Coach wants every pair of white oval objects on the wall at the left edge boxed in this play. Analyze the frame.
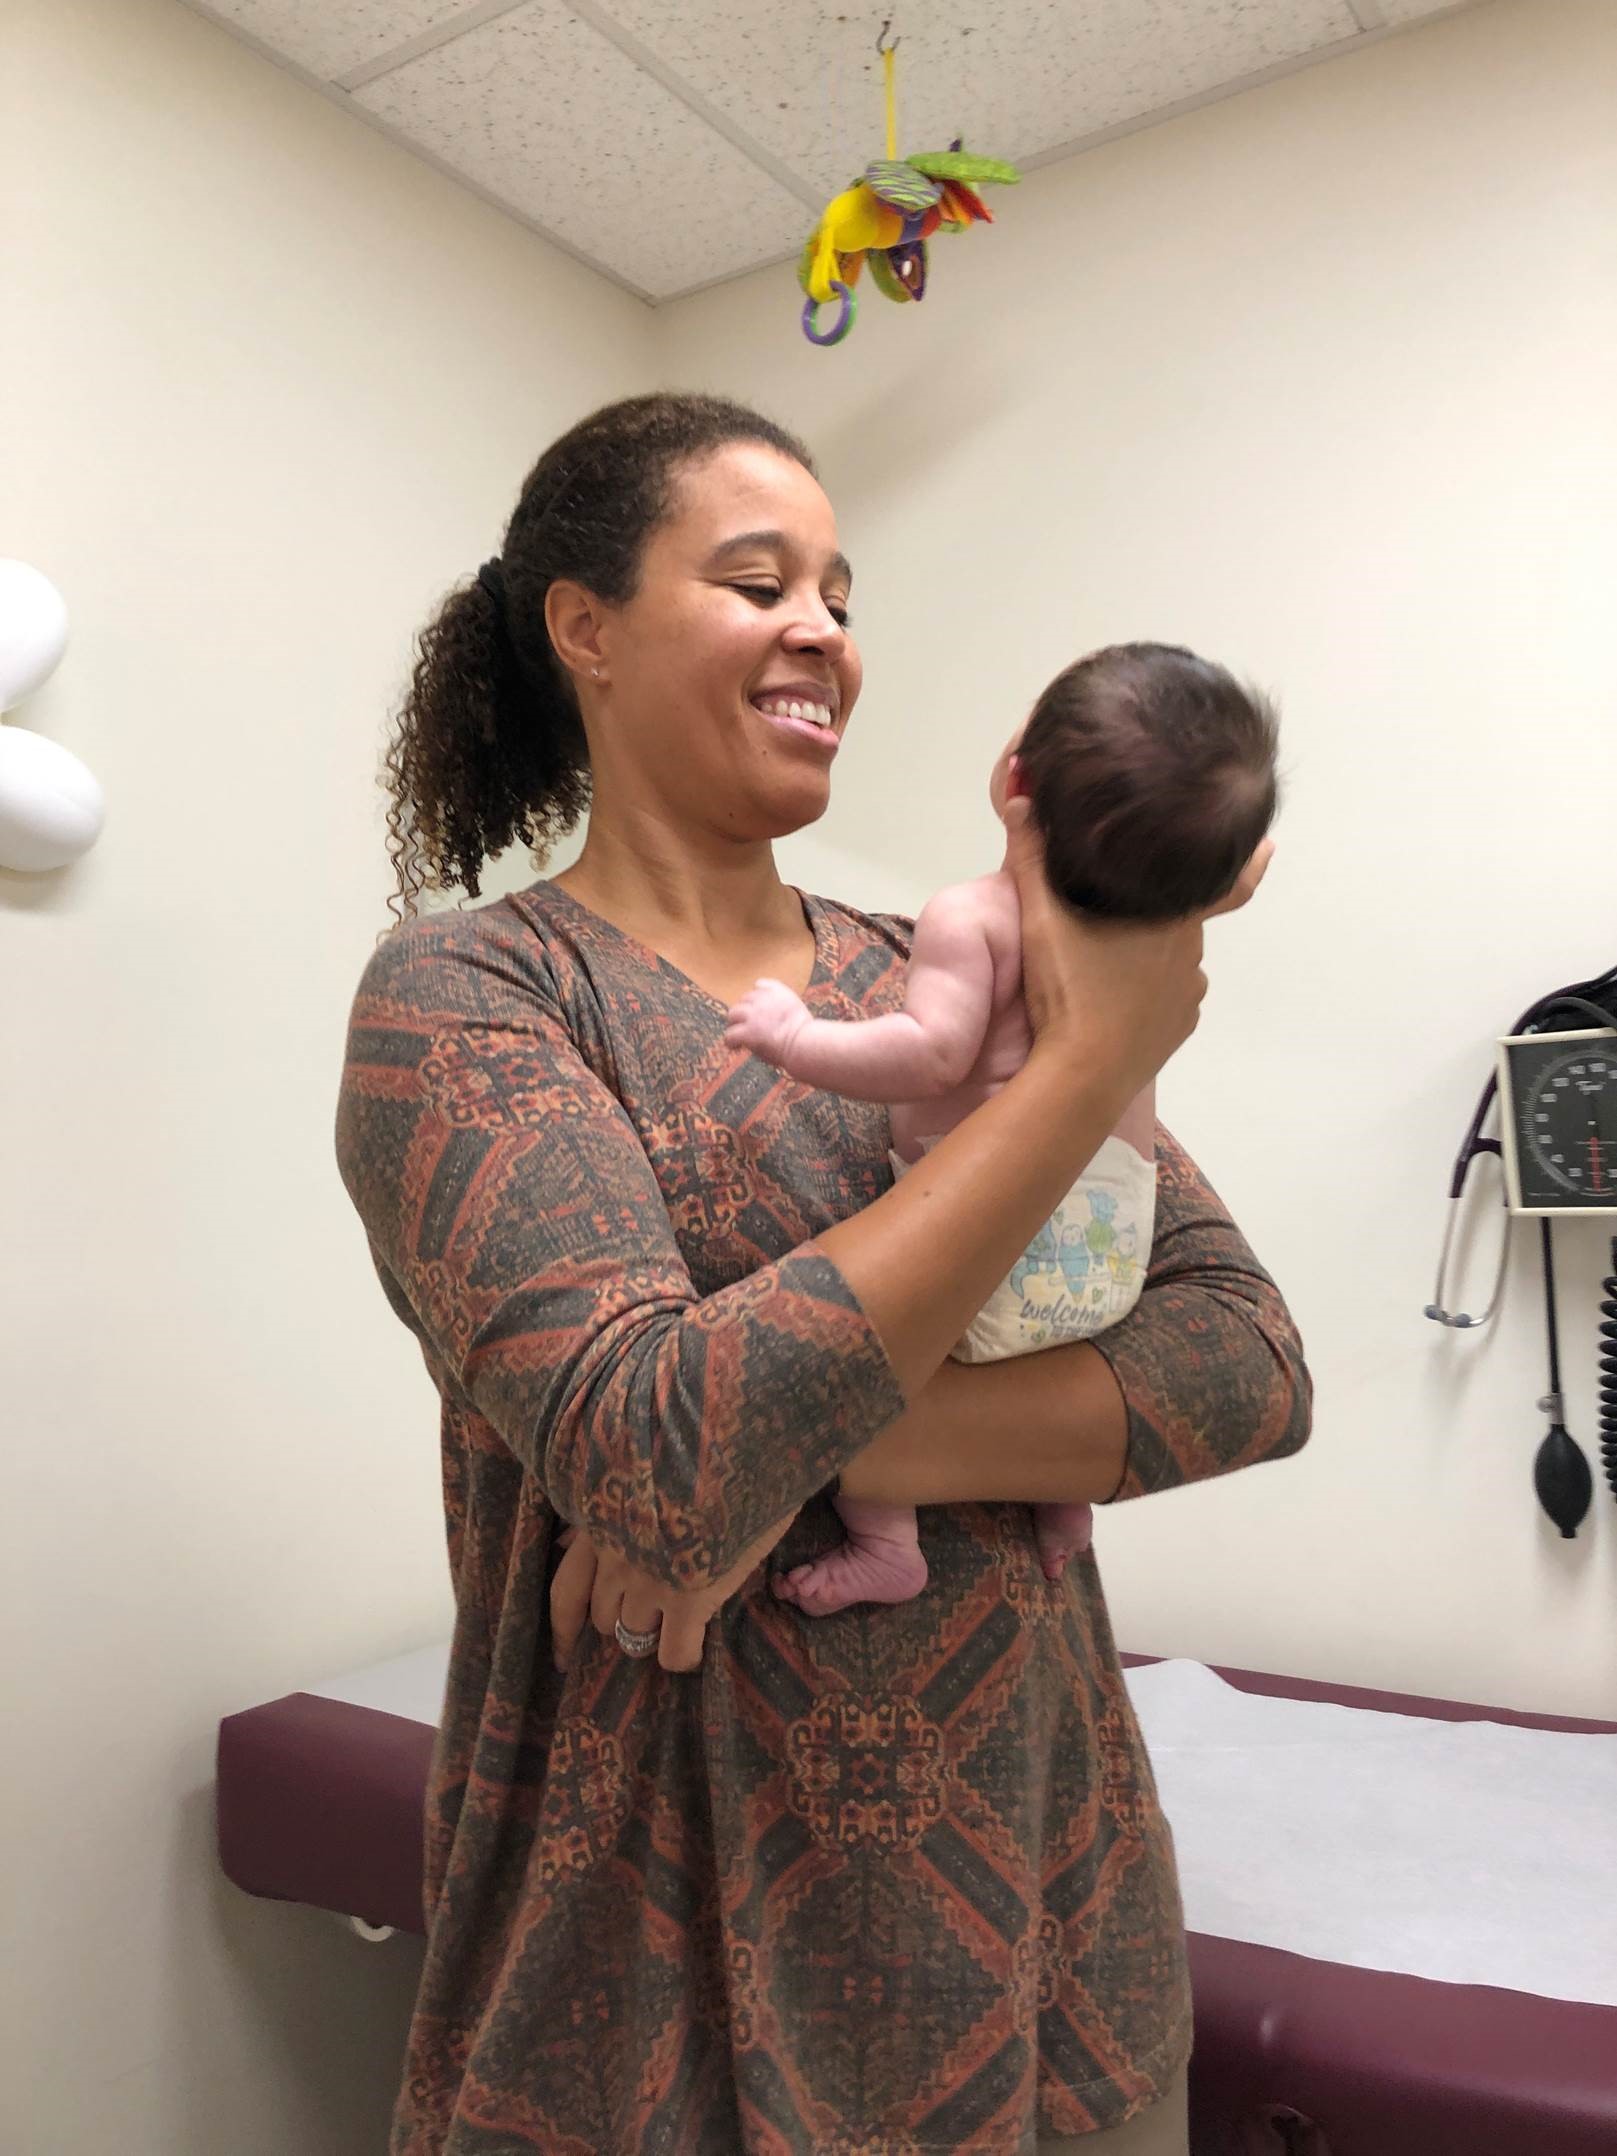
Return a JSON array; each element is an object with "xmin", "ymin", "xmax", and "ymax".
[{"xmin": 0, "ymin": 556, "xmax": 106, "ymax": 875}]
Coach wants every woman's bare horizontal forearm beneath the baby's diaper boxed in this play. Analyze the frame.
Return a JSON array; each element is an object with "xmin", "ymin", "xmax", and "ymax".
[{"xmin": 841, "ymin": 1341, "xmax": 1128, "ymax": 1505}]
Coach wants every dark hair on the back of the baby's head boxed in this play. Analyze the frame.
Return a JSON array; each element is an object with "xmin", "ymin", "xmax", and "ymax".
[{"xmin": 1018, "ymin": 645, "xmax": 1279, "ymax": 921}]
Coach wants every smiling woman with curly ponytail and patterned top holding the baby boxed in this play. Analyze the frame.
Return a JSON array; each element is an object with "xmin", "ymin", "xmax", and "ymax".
[{"xmin": 338, "ymin": 397, "xmax": 1309, "ymax": 2156}]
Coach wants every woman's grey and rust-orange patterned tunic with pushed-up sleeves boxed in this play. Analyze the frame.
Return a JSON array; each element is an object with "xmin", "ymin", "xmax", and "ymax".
[{"xmin": 338, "ymin": 884, "xmax": 1309, "ymax": 2156}]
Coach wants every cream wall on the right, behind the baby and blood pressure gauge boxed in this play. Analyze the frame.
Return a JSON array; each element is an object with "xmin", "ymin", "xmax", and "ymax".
[{"xmin": 664, "ymin": 0, "xmax": 1617, "ymax": 1714}]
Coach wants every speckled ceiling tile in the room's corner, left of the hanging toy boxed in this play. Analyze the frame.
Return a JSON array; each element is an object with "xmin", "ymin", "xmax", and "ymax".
[{"xmin": 354, "ymin": 0, "xmax": 813, "ymax": 298}]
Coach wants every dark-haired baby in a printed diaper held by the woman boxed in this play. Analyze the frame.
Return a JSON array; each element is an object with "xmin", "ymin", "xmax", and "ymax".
[{"xmin": 724, "ymin": 645, "xmax": 1279, "ymax": 1617}]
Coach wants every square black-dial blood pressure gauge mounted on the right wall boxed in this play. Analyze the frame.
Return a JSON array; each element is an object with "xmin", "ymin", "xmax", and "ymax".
[{"xmin": 1498, "ymin": 1026, "xmax": 1617, "ymax": 1214}]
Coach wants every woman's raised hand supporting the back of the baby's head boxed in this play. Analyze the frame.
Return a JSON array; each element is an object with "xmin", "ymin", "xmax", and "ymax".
[{"xmin": 1005, "ymin": 793, "xmax": 1274, "ymax": 1100}]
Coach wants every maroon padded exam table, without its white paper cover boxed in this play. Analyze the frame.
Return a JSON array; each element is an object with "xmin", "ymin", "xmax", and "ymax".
[{"xmin": 218, "ymin": 1656, "xmax": 1617, "ymax": 2156}]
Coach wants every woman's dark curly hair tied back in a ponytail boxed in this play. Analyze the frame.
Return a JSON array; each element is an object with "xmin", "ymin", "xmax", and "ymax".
[{"xmin": 384, "ymin": 392, "xmax": 815, "ymax": 914}]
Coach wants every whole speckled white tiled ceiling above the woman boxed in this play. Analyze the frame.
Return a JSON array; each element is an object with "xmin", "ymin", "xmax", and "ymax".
[{"xmin": 190, "ymin": 0, "xmax": 1475, "ymax": 300}]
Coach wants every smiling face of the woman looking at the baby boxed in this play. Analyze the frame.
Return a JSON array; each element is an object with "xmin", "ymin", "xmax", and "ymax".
[{"xmin": 580, "ymin": 442, "xmax": 860, "ymax": 841}]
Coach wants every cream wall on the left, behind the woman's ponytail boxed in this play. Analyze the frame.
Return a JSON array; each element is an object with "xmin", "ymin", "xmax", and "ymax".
[{"xmin": 0, "ymin": 0, "xmax": 653, "ymax": 2156}]
